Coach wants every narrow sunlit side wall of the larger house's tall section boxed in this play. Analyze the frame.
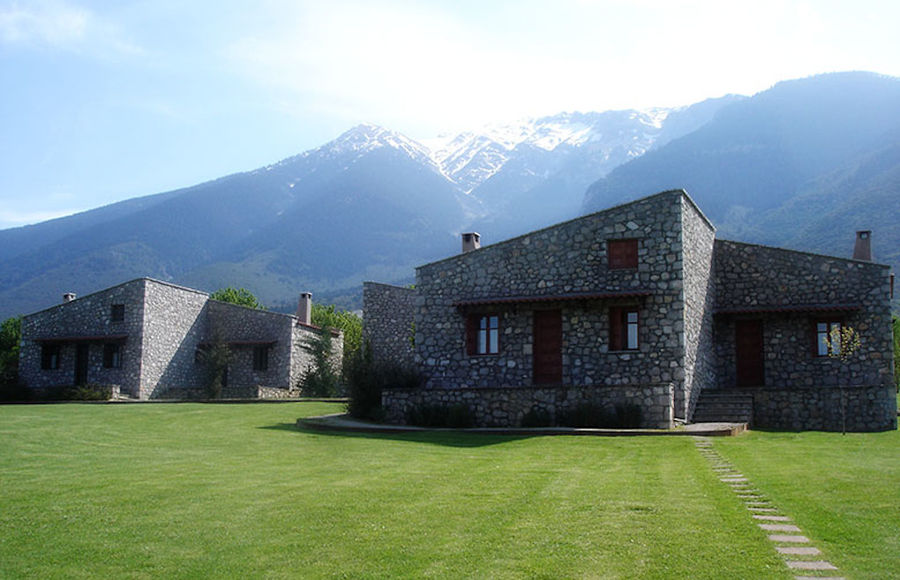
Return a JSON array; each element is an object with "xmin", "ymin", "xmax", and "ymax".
[{"xmin": 675, "ymin": 196, "xmax": 716, "ymax": 419}]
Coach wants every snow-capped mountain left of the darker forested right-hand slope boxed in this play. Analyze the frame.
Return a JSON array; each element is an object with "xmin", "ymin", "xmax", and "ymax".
[{"xmin": 0, "ymin": 97, "xmax": 737, "ymax": 318}]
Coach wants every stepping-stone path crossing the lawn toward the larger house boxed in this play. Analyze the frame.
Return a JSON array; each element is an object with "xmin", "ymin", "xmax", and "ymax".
[{"xmin": 694, "ymin": 437, "xmax": 844, "ymax": 580}]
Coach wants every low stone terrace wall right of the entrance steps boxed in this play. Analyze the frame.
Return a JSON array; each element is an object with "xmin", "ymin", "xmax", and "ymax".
[{"xmin": 741, "ymin": 385, "xmax": 897, "ymax": 431}]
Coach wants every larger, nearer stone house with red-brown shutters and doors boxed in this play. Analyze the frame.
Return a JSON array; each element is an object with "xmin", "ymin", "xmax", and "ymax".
[{"xmin": 364, "ymin": 190, "xmax": 897, "ymax": 430}]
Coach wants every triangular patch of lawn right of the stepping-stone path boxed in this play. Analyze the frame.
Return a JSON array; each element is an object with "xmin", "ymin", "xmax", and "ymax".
[{"xmin": 715, "ymin": 431, "xmax": 900, "ymax": 579}]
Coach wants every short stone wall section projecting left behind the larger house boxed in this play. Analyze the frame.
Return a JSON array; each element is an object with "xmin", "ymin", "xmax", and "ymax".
[{"xmin": 363, "ymin": 282, "xmax": 416, "ymax": 364}]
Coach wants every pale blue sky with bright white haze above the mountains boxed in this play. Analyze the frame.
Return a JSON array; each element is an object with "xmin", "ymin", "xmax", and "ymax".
[{"xmin": 0, "ymin": 0, "xmax": 900, "ymax": 229}]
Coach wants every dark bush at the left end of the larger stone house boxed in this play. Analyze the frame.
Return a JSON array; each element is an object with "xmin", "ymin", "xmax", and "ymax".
[{"xmin": 344, "ymin": 343, "xmax": 422, "ymax": 421}]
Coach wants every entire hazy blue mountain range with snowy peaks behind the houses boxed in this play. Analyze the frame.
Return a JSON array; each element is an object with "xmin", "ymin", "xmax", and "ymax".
[{"xmin": 0, "ymin": 73, "xmax": 900, "ymax": 318}]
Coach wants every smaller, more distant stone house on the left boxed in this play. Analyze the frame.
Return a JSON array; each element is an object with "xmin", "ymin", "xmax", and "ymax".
[{"xmin": 19, "ymin": 278, "xmax": 343, "ymax": 399}]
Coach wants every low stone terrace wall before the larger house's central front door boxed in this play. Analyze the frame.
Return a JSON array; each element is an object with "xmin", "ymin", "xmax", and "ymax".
[{"xmin": 381, "ymin": 383, "xmax": 674, "ymax": 429}]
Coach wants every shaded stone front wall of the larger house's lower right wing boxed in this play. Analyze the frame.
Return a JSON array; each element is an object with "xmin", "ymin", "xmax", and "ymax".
[{"xmin": 715, "ymin": 240, "xmax": 893, "ymax": 388}]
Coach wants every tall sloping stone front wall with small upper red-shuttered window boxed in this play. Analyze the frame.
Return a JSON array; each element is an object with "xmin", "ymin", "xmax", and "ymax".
[{"xmin": 416, "ymin": 191, "xmax": 685, "ymax": 392}]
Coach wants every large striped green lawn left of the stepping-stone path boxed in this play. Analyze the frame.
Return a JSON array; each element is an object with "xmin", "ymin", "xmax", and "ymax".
[{"xmin": 7, "ymin": 403, "xmax": 796, "ymax": 578}]
